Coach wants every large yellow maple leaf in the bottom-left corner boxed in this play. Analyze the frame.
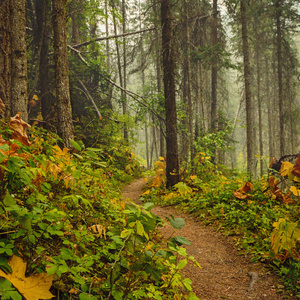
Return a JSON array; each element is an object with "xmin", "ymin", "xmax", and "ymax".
[{"xmin": 0, "ymin": 255, "xmax": 54, "ymax": 300}]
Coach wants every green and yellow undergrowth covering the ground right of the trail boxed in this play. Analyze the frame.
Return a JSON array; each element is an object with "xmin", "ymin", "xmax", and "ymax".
[{"xmin": 142, "ymin": 152, "xmax": 300, "ymax": 298}]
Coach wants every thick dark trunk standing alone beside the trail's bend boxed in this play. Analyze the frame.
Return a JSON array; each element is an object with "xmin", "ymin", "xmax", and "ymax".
[{"xmin": 161, "ymin": 0, "xmax": 179, "ymax": 187}]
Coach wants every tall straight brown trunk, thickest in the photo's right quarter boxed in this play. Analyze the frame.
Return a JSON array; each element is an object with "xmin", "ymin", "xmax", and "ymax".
[{"xmin": 241, "ymin": 0, "xmax": 255, "ymax": 175}]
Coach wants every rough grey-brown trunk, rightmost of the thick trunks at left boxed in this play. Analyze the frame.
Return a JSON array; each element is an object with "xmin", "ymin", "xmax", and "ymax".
[{"xmin": 52, "ymin": 0, "xmax": 74, "ymax": 148}]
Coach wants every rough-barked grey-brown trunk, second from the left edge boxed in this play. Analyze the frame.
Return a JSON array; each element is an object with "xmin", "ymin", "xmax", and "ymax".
[{"xmin": 10, "ymin": 0, "xmax": 28, "ymax": 122}]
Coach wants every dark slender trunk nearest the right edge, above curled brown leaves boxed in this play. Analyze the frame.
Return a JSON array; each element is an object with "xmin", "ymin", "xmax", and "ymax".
[{"xmin": 275, "ymin": 0, "xmax": 284, "ymax": 156}]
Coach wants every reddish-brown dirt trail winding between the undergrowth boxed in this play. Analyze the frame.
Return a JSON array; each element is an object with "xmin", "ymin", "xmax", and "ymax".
[{"xmin": 122, "ymin": 179, "xmax": 296, "ymax": 300}]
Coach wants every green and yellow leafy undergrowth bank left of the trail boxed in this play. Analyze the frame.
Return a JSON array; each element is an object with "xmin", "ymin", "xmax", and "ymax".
[{"xmin": 0, "ymin": 115, "xmax": 198, "ymax": 300}]
